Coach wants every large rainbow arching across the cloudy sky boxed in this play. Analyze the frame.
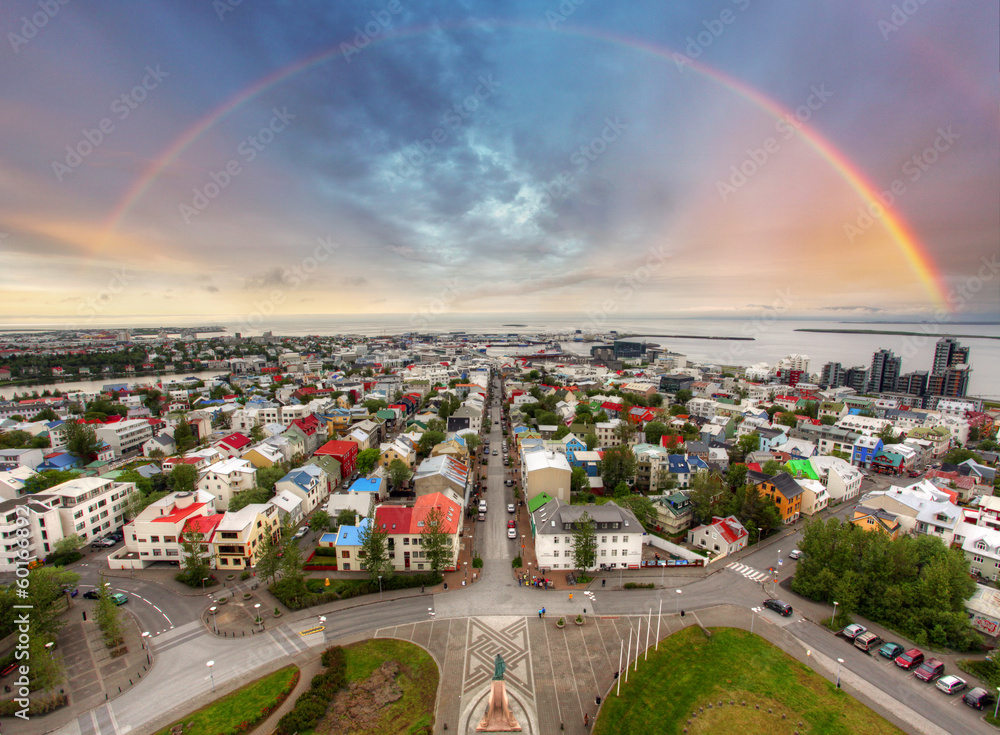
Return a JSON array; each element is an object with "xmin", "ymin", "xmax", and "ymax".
[{"xmin": 102, "ymin": 20, "xmax": 951, "ymax": 310}]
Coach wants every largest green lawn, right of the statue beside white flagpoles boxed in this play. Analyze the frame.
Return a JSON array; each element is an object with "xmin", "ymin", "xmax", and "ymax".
[{"xmin": 594, "ymin": 627, "xmax": 902, "ymax": 735}]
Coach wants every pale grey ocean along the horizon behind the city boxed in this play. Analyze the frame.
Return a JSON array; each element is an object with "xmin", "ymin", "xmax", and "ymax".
[{"xmin": 0, "ymin": 314, "xmax": 1000, "ymax": 399}]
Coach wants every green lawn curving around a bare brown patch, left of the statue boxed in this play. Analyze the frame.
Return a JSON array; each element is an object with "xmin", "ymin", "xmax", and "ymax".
[{"xmin": 324, "ymin": 638, "xmax": 438, "ymax": 735}]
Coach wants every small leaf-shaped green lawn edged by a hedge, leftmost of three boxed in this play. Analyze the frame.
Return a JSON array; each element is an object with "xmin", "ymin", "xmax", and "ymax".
[{"xmin": 148, "ymin": 665, "xmax": 299, "ymax": 735}]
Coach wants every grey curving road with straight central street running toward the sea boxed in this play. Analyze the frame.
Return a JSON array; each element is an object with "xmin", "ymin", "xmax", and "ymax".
[{"xmin": 43, "ymin": 391, "xmax": 994, "ymax": 735}]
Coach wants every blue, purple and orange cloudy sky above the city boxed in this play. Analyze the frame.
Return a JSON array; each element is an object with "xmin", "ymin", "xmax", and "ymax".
[{"xmin": 0, "ymin": 0, "xmax": 1000, "ymax": 324}]
